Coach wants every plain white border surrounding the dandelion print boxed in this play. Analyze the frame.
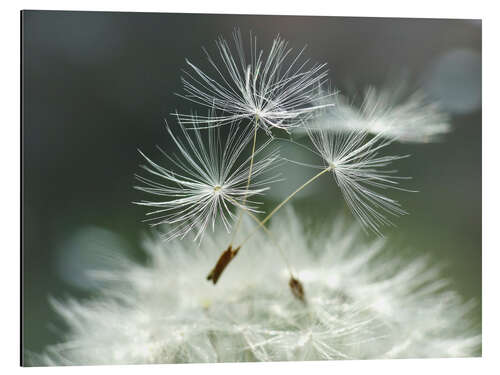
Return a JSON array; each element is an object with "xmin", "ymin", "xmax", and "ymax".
[{"xmin": 0, "ymin": 0, "xmax": 500, "ymax": 375}]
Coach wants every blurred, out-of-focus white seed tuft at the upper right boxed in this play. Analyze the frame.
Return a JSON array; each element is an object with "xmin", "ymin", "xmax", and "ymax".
[{"xmin": 297, "ymin": 84, "xmax": 451, "ymax": 143}]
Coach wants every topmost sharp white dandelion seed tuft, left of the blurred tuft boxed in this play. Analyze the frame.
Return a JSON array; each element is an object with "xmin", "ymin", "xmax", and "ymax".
[{"xmin": 179, "ymin": 30, "xmax": 332, "ymax": 133}]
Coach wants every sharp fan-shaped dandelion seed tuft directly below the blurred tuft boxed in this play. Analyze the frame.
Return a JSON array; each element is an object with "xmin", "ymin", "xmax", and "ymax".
[{"xmin": 309, "ymin": 130, "xmax": 410, "ymax": 235}]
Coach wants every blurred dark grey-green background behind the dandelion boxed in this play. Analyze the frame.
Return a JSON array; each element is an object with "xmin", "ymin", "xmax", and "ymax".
[{"xmin": 22, "ymin": 11, "xmax": 481, "ymax": 358}]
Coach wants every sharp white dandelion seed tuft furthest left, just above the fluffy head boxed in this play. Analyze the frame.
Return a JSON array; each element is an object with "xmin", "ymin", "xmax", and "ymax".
[{"xmin": 135, "ymin": 117, "xmax": 278, "ymax": 240}]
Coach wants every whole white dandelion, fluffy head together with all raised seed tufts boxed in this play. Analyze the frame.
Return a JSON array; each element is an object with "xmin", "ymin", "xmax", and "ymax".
[{"xmin": 32, "ymin": 30, "xmax": 470, "ymax": 365}]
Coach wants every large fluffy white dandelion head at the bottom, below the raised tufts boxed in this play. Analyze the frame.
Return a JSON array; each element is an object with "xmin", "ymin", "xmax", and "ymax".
[{"xmin": 32, "ymin": 211, "xmax": 481, "ymax": 365}]
